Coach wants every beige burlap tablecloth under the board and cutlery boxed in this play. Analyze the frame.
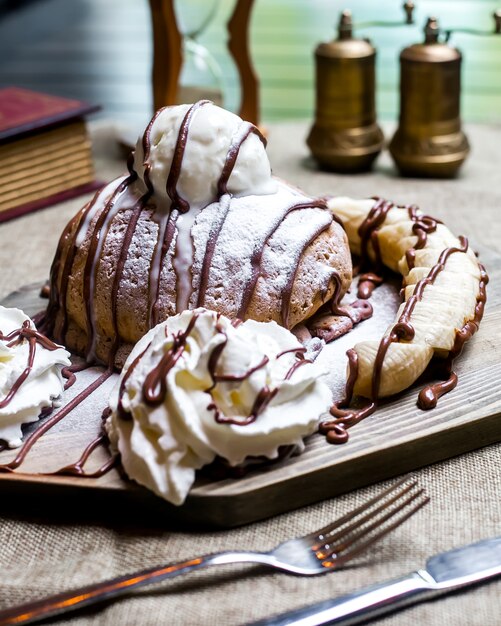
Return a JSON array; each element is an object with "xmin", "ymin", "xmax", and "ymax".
[{"xmin": 0, "ymin": 119, "xmax": 501, "ymax": 626}]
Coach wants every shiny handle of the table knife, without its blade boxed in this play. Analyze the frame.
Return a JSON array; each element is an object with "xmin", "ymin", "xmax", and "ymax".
[{"xmin": 252, "ymin": 570, "xmax": 436, "ymax": 626}]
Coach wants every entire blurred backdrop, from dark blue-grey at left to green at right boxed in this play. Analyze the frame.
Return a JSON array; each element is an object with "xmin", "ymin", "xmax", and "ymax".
[{"xmin": 0, "ymin": 0, "xmax": 501, "ymax": 126}]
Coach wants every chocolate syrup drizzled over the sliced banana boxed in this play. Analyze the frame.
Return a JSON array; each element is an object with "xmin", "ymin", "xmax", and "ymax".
[{"xmin": 319, "ymin": 200, "xmax": 488, "ymax": 444}]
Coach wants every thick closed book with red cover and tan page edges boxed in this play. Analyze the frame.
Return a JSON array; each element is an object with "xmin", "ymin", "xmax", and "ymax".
[{"xmin": 0, "ymin": 87, "xmax": 99, "ymax": 222}]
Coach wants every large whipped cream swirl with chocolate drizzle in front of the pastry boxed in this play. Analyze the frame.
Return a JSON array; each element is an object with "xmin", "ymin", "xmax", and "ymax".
[{"xmin": 107, "ymin": 309, "xmax": 332, "ymax": 505}]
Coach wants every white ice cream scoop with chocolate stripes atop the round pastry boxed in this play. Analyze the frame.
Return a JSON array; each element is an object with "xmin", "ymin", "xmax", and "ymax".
[{"xmin": 134, "ymin": 103, "xmax": 277, "ymax": 207}]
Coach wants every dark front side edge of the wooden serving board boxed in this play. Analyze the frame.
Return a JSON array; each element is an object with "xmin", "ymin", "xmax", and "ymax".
[{"xmin": 1, "ymin": 404, "xmax": 501, "ymax": 530}]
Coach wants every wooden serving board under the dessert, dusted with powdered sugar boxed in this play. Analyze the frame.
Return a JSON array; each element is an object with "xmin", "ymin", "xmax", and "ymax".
[{"xmin": 0, "ymin": 241, "xmax": 501, "ymax": 528}]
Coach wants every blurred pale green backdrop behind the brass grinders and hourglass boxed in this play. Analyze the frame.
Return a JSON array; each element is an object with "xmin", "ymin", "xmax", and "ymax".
[{"xmin": 186, "ymin": 0, "xmax": 501, "ymax": 122}]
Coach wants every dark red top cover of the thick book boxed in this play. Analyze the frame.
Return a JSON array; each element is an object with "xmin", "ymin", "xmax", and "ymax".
[{"xmin": 0, "ymin": 87, "xmax": 100, "ymax": 144}]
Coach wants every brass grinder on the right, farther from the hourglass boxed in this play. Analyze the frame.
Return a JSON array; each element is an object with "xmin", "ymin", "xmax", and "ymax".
[{"xmin": 389, "ymin": 17, "xmax": 470, "ymax": 178}]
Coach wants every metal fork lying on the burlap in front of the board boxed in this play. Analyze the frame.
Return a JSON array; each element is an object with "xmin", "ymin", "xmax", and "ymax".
[{"xmin": 0, "ymin": 478, "xmax": 429, "ymax": 626}]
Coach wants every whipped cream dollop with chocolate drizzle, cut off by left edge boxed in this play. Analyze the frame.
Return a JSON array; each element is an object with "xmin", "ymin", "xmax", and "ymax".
[{"xmin": 0, "ymin": 306, "xmax": 71, "ymax": 448}]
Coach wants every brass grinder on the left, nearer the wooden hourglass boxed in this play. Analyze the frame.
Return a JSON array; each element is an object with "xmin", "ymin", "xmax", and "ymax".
[{"xmin": 306, "ymin": 11, "xmax": 383, "ymax": 172}]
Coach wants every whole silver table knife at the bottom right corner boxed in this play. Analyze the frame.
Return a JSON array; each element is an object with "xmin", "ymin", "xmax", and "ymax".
[{"xmin": 249, "ymin": 537, "xmax": 501, "ymax": 626}]
